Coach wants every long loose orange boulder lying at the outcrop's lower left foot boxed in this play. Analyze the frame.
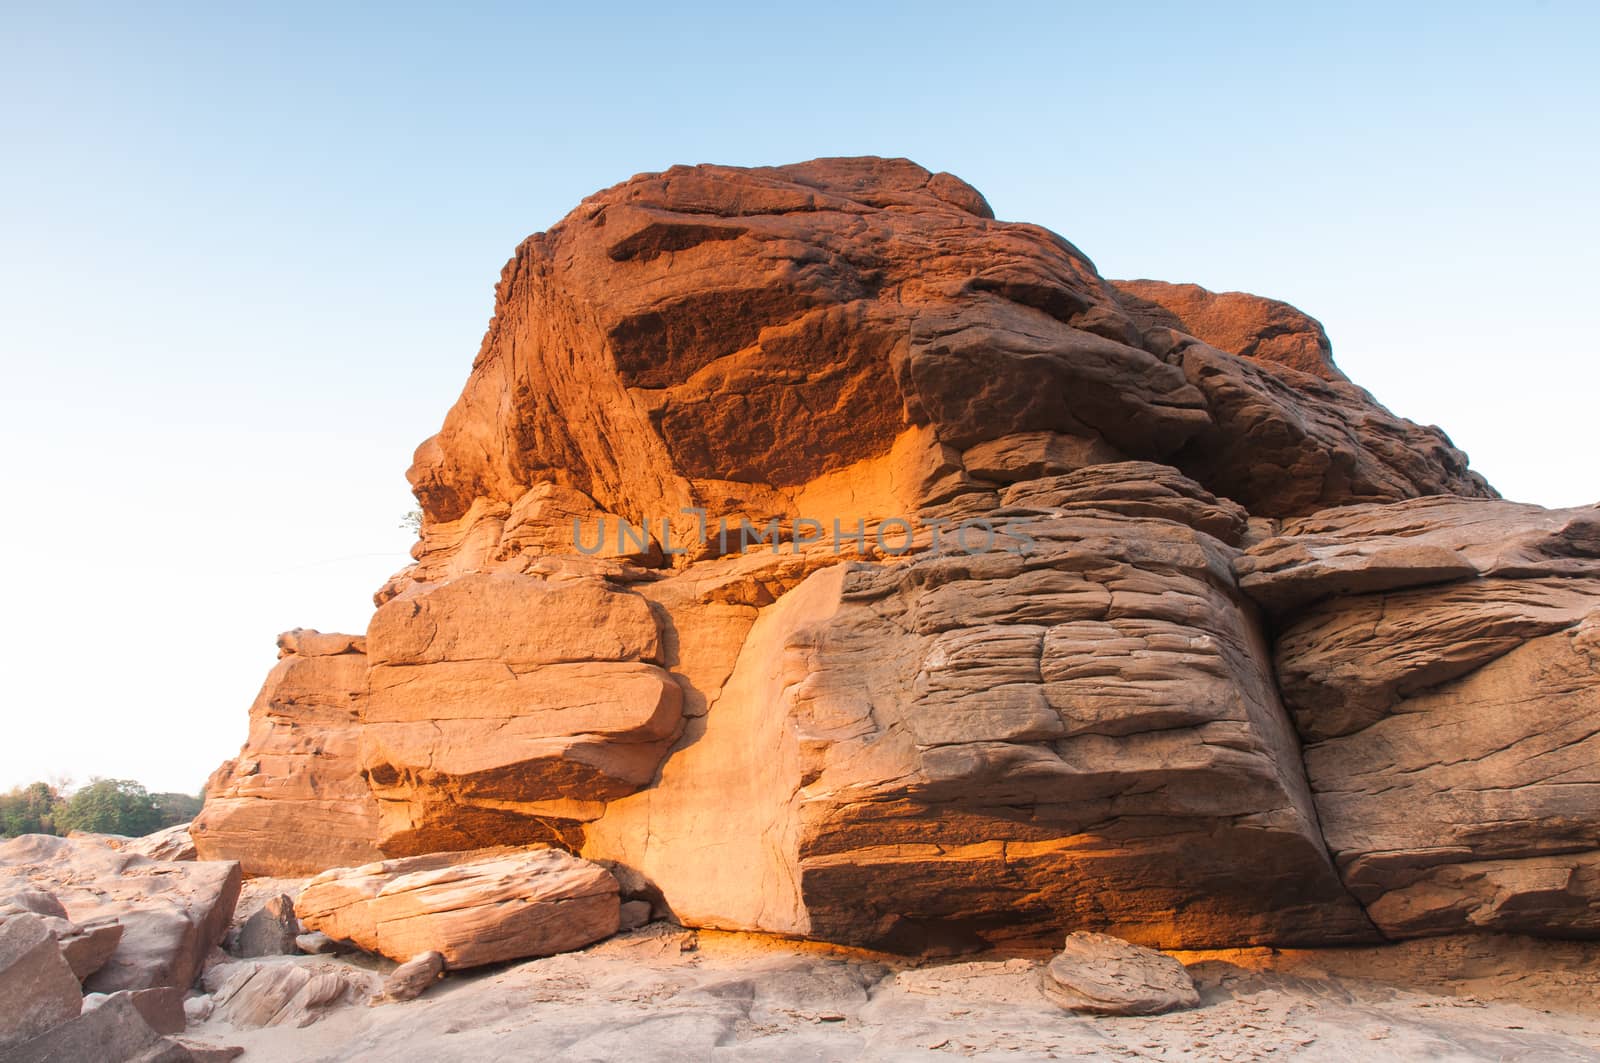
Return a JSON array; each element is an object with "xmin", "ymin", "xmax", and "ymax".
[{"xmin": 294, "ymin": 848, "xmax": 619, "ymax": 970}]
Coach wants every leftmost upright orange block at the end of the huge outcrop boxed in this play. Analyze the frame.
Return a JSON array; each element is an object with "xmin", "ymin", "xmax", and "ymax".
[{"xmin": 190, "ymin": 629, "xmax": 381, "ymax": 876}]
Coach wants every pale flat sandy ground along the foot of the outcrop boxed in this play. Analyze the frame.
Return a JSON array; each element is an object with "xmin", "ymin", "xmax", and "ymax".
[{"xmin": 187, "ymin": 925, "xmax": 1600, "ymax": 1063}]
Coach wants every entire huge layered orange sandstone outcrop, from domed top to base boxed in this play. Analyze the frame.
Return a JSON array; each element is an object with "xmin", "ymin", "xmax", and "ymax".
[{"xmin": 195, "ymin": 158, "xmax": 1600, "ymax": 965}]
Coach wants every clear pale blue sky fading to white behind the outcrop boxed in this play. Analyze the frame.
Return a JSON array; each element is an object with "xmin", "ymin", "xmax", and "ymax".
[{"xmin": 0, "ymin": 2, "xmax": 1600, "ymax": 791}]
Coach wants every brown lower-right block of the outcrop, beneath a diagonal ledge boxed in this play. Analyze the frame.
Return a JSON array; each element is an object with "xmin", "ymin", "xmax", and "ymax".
[{"xmin": 1306, "ymin": 614, "xmax": 1600, "ymax": 937}]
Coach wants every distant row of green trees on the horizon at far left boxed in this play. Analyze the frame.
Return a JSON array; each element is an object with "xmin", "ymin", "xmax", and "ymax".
[{"xmin": 0, "ymin": 778, "xmax": 202, "ymax": 837}]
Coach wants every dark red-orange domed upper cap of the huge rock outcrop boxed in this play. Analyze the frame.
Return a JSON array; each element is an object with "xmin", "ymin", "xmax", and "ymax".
[{"xmin": 396, "ymin": 158, "xmax": 1485, "ymax": 563}]
